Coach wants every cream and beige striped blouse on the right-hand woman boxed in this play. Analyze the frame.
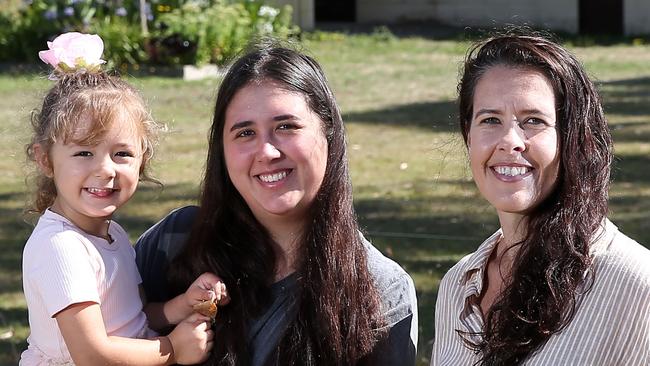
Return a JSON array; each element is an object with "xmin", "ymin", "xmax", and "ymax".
[{"xmin": 431, "ymin": 220, "xmax": 650, "ymax": 366}]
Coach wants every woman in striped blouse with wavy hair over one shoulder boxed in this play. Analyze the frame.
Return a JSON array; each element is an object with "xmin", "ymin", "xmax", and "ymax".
[{"xmin": 431, "ymin": 30, "xmax": 650, "ymax": 366}]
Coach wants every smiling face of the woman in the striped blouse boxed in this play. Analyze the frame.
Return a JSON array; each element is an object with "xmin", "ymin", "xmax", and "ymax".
[{"xmin": 468, "ymin": 66, "xmax": 560, "ymax": 217}]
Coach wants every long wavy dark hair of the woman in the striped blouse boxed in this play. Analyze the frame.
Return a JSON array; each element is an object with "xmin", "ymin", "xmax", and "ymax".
[{"xmin": 458, "ymin": 29, "xmax": 612, "ymax": 365}]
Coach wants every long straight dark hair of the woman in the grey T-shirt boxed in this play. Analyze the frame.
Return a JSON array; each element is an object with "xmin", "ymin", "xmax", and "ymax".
[{"xmin": 170, "ymin": 45, "xmax": 382, "ymax": 365}]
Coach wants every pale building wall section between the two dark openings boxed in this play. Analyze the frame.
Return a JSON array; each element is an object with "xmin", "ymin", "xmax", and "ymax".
[{"xmin": 357, "ymin": 0, "xmax": 576, "ymax": 32}]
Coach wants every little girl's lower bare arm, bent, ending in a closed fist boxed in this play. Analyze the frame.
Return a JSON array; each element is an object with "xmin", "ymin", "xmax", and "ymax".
[{"xmin": 55, "ymin": 302, "xmax": 214, "ymax": 366}]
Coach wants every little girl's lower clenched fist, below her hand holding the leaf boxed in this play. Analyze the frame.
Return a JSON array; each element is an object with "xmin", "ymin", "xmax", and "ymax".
[{"xmin": 167, "ymin": 313, "xmax": 214, "ymax": 365}]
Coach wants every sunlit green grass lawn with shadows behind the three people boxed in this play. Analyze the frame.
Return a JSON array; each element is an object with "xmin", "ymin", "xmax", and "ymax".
[{"xmin": 0, "ymin": 27, "xmax": 650, "ymax": 365}]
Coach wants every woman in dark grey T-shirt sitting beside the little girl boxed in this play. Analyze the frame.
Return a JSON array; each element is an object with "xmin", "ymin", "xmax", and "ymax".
[{"xmin": 136, "ymin": 46, "xmax": 417, "ymax": 365}]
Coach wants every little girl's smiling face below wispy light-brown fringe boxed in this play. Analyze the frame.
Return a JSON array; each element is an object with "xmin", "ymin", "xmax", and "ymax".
[{"xmin": 39, "ymin": 113, "xmax": 142, "ymax": 236}]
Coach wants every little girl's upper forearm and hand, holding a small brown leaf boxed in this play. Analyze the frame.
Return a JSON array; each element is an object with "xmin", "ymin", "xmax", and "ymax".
[{"xmin": 140, "ymin": 272, "xmax": 229, "ymax": 330}]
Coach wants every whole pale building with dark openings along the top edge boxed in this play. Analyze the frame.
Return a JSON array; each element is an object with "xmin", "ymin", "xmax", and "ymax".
[{"xmin": 275, "ymin": 0, "xmax": 650, "ymax": 35}]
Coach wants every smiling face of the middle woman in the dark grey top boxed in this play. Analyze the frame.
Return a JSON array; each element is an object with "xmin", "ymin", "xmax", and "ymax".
[{"xmin": 223, "ymin": 81, "xmax": 327, "ymax": 226}]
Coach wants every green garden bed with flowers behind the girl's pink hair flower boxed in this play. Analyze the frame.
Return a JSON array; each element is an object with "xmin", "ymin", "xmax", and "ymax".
[{"xmin": 0, "ymin": 0, "xmax": 299, "ymax": 69}]
